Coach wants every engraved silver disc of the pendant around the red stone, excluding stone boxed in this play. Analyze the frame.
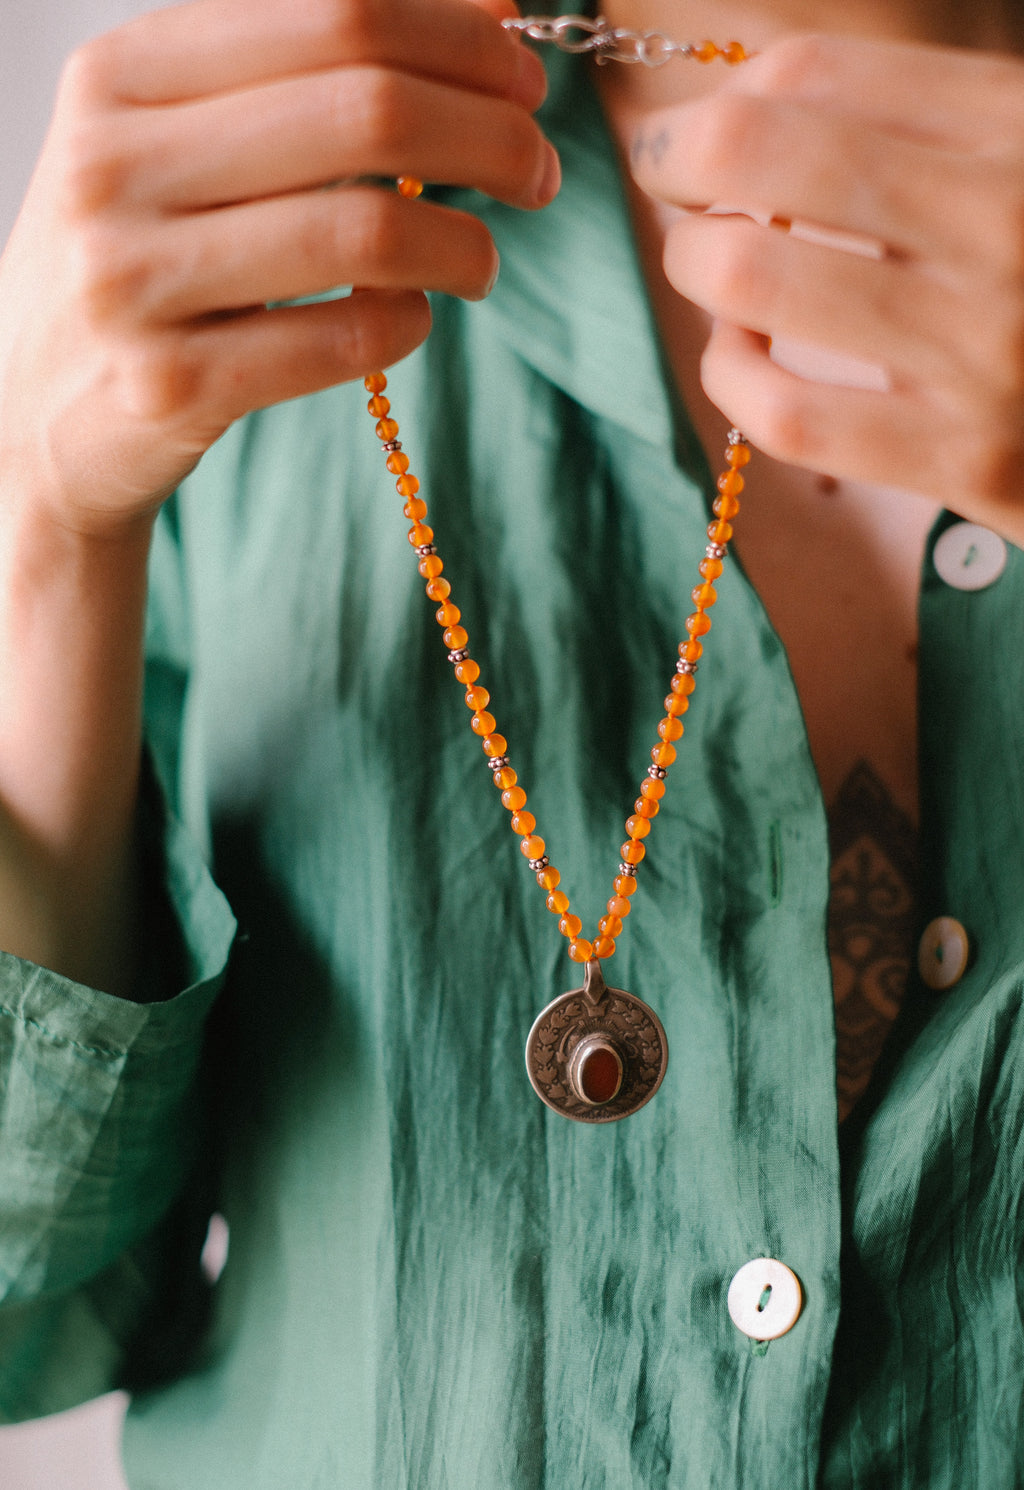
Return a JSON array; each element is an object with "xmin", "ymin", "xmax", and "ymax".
[{"xmin": 526, "ymin": 958, "xmax": 668, "ymax": 1123}]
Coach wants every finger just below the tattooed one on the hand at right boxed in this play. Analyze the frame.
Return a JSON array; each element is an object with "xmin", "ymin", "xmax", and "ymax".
[{"xmin": 665, "ymin": 218, "xmax": 993, "ymax": 386}]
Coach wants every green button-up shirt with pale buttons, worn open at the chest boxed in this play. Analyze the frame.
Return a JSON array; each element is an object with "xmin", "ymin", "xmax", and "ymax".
[{"xmin": 0, "ymin": 46, "xmax": 1024, "ymax": 1490}]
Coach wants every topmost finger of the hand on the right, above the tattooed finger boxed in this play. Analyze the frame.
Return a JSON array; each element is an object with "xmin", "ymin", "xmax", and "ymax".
[{"xmin": 742, "ymin": 34, "xmax": 1024, "ymax": 153}]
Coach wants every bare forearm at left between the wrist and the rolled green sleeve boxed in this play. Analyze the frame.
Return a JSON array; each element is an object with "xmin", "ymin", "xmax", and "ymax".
[{"xmin": 0, "ymin": 507, "xmax": 151, "ymax": 994}]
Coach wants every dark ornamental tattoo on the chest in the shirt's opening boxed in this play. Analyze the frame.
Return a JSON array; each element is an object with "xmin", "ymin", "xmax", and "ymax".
[{"xmin": 829, "ymin": 761, "xmax": 917, "ymax": 1120}]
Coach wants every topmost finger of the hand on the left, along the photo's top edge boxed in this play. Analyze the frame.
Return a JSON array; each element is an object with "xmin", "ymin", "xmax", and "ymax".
[{"xmin": 72, "ymin": 0, "xmax": 546, "ymax": 109}]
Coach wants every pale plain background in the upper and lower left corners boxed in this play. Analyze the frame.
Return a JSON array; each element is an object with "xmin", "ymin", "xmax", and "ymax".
[{"xmin": 0, "ymin": 14, "xmax": 152, "ymax": 1490}]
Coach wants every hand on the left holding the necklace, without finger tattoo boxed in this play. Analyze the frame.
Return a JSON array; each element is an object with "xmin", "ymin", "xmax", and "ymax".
[{"xmin": 0, "ymin": 0, "xmax": 559, "ymax": 535}]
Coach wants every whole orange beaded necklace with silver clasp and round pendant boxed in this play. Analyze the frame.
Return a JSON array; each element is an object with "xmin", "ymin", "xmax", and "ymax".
[{"xmin": 364, "ymin": 15, "xmax": 750, "ymax": 1123}]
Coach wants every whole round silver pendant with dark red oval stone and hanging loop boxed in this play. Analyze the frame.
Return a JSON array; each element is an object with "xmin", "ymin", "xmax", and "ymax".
[{"xmin": 526, "ymin": 958, "xmax": 668, "ymax": 1122}]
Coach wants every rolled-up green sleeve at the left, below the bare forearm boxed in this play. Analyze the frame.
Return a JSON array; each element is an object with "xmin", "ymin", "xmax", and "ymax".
[{"xmin": 0, "ymin": 780, "xmax": 234, "ymax": 1420}]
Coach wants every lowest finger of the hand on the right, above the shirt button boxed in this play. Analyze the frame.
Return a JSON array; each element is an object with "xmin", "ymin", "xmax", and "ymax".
[{"xmin": 701, "ymin": 322, "xmax": 1024, "ymax": 509}]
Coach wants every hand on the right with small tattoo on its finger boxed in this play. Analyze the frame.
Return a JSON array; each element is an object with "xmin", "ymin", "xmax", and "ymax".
[{"xmin": 633, "ymin": 36, "xmax": 1024, "ymax": 544}]
